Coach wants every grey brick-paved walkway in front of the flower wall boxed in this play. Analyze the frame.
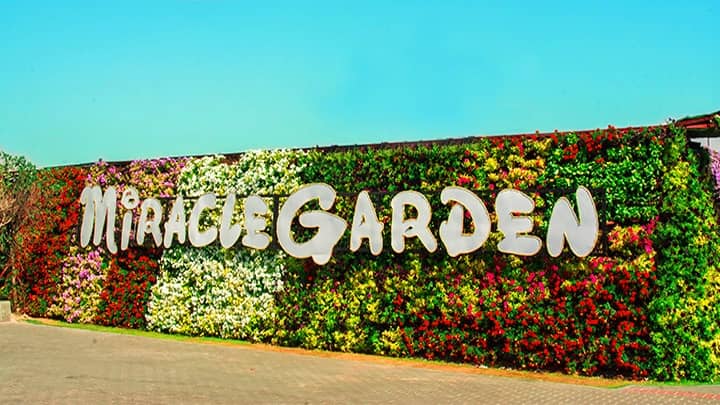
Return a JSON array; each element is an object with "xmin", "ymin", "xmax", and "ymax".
[{"xmin": 0, "ymin": 322, "xmax": 720, "ymax": 405}]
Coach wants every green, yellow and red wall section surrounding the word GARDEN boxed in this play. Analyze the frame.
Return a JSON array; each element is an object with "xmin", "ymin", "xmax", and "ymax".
[{"xmin": 272, "ymin": 136, "xmax": 662, "ymax": 378}]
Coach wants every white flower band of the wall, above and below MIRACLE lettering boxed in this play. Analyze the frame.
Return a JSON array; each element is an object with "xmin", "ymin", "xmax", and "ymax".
[{"xmin": 146, "ymin": 150, "xmax": 302, "ymax": 341}]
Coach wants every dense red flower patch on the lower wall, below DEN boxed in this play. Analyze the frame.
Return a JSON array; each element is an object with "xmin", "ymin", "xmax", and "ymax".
[{"xmin": 393, "ymin": 246, "xmax": 654, "ymax": 379}]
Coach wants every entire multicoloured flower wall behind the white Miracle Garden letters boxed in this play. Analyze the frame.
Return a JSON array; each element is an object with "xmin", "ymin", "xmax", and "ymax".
[{"xmin": 13, "ymin": 126, "xmax": 720, "ymax": 381}]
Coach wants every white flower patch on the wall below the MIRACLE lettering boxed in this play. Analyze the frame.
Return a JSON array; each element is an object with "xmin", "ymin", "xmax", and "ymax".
[{"xmin": 146, "ymin": 246, "xmax": 282, "ymax": 341}]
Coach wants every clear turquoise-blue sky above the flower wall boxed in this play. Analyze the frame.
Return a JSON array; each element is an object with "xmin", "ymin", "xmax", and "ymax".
[{"xmin": 0, "ymin": 0, "xmax": 720, "ymax": 166}]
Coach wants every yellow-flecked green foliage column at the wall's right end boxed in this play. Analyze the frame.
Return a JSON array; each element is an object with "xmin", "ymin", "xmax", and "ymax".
[{"xmin": 648, "ymin": 127, "xmax": 720, "ymax": 381}]
